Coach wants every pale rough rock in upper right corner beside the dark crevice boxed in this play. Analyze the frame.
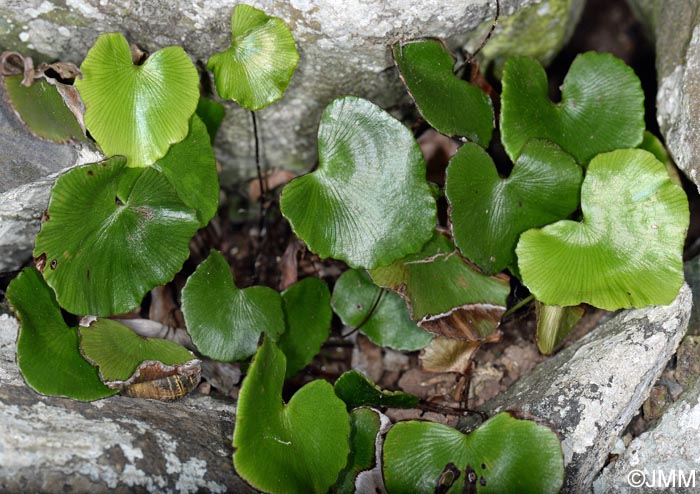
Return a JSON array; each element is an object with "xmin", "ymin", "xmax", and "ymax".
[{"xmin": 628, "ymin": 0, "xmax": 700, "ymax": 191}]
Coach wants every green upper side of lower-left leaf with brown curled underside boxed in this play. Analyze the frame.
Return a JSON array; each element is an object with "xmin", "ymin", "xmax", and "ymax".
[{"xmin": 79, "ymin": 319, "xmax": 195, "ymax": 384}]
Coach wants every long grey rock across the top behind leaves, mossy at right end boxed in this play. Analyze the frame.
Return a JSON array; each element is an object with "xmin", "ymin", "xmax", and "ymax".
[{"xmin": 0, "ymin": 0, "xmax": 584, "ymax": 182}]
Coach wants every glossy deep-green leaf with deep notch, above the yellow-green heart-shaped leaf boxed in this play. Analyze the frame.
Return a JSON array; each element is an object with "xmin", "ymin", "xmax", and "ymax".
[{"xmin": 501, "ymin": 52, "xmax": 645, "ymax": 166}]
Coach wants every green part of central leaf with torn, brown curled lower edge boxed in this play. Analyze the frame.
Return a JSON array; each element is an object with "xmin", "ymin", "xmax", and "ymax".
[{"xmin": 370, "ymin": 233, "xmax": 510, "ymax": 321}]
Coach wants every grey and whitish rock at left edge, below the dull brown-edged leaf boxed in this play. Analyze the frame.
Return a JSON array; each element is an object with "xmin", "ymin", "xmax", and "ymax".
[{"xmin": 0, "ymin": 81, "xmax": 101, "ymax": 273}]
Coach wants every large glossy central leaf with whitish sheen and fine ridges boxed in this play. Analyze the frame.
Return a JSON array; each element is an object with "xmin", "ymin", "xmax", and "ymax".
[{"xmin": 280, "ymin": 97, "xmax": 436, "ymax": 268}]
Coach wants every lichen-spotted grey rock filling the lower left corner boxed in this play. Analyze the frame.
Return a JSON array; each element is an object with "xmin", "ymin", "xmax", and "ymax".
[{"xmin": 0, "ymin": 314, "xmax": 256, "ymax": 493}]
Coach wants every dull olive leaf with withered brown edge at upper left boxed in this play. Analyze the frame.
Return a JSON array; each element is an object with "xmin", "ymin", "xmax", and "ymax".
[{"xmin": 2, "ymin": 75, "xmax": 85, "ymax": 142}]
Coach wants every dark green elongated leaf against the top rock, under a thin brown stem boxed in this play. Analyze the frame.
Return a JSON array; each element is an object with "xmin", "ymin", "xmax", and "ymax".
[{"xmin": 393, "ymin": 39, "xmax": 494, "ymax": 147}]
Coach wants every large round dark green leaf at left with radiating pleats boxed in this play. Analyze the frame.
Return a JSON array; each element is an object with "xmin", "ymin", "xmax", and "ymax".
[{"xmin": 34, "ymin": 156, "xmax": 199, "ymax": 316}]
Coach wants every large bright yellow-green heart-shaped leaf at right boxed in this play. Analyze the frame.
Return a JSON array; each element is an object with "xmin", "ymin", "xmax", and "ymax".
[{"xmin": 516, "ymin": 149, "xmax": 688, "ymax": 310}]
